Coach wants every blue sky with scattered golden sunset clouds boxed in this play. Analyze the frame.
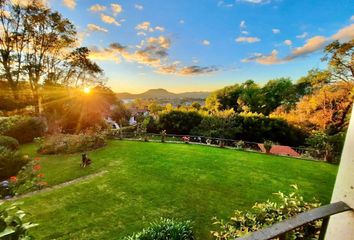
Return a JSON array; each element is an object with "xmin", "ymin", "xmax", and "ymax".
[{"xmin": 43, "ymin": 0, "xmax": 354, "ymax": 93}]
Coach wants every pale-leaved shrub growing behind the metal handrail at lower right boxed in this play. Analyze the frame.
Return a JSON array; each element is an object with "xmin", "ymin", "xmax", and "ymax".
[{"xmin": 212, "ymin": 185, "xmax": 321, "ymax": 240}]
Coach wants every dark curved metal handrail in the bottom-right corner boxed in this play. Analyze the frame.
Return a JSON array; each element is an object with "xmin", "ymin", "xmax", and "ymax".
[{"xmin": 237, "ymin": 202, "xmax": 353, "ymax": 240}]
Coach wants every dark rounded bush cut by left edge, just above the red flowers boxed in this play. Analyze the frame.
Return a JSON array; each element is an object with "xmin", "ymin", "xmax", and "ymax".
[{"xmin": 0, "ymin": 146, "xmax": 28, "ymax": 180}]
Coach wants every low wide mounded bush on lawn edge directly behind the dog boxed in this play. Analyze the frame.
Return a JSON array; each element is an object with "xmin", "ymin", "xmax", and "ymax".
[{"xmin": 38, "ymin": 134, "xmax": 106, "ymax": 154}]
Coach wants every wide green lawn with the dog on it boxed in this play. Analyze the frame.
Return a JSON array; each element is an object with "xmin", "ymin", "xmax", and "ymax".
[{"xmin": 16, "ymin": 141, "xmax": 337, "ymax": 240}]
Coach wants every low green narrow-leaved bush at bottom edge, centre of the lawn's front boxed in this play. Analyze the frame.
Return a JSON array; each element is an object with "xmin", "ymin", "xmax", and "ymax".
[{"xmin": 124, "ymin": 219, "xmax": 195, "ymax": 240}]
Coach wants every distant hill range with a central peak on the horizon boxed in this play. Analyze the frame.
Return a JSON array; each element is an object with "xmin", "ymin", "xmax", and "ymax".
[{"xmin": 117, "ymin": 88, "xmax": 210, "ymax": 99}]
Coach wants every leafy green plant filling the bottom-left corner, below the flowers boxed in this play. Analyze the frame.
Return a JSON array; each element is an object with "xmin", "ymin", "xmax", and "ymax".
[{"xmin": 0, "ymin": 202, "xmax": 38, "ymax": 240}]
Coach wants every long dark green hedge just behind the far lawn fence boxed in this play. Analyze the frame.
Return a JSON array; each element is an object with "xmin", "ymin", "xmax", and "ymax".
[{"xmin": 144, "ymin": 110, "xmax": 307, "ymax": 146}]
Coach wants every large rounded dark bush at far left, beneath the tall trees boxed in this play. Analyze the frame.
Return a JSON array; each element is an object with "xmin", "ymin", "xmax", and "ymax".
[{"xmin": 3, "ymin": 117, "xmax": 47, "ymax": 144}]
